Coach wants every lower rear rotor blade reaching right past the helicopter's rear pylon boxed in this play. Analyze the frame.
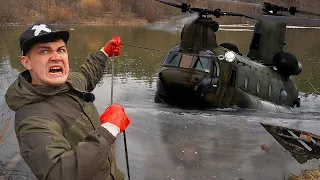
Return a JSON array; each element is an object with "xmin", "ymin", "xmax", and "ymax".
[{"xmin": 243, "ymin": 14, "xmax": 320, "ymax": 26}]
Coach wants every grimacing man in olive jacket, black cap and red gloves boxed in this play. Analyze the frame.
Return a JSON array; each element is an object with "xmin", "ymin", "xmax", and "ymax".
[{"xmin": 5, "ymin": 24, "xmax": 130, "ymax": 180}]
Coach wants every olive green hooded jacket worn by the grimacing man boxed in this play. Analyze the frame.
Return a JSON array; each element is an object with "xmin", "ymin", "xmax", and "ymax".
[{"xmin": 5, "ymin": 51, "xmax": 124, "ymax": 180}]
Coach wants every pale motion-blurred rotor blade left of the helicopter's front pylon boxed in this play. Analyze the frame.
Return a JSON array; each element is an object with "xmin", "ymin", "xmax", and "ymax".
[{"xmin": 147, "ymin": 12, "xmax": 199, "ymax": 33}]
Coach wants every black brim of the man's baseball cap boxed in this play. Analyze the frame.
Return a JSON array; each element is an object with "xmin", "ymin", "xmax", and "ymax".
[{"xmin": 22, "ymin": 31, "xmax": 69, "ymax": 55}]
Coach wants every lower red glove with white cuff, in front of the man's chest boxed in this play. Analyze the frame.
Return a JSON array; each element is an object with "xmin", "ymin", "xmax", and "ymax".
[{"xmin": 100, "ymin": 104, "xmax": 130, "ymax": 133}]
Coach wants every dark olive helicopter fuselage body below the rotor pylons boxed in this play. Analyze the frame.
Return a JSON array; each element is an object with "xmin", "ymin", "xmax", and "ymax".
[{"xmin": 155, "ymin": 46, "xmax": 298, "ymax": 111}]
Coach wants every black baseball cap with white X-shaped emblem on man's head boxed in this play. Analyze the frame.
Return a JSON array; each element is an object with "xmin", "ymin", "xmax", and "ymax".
[{"xmin": 19, "ymin": 24, "xmax": 69, "ymax": 56}]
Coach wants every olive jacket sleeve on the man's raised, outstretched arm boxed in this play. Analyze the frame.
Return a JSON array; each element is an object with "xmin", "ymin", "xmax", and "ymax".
[{"xmin": 69, "ymin": 51, "xmax": 108, "ymax": 92}]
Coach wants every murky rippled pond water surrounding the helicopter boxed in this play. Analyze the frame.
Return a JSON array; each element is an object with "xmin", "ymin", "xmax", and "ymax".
[{"xmin": 0, "ymin": 26, "xmax": 320, "ymax": 180}]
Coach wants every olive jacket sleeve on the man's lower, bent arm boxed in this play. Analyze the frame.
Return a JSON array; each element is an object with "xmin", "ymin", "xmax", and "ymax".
[{"xmin": 17, "ymin": 117, "xmax": 115, "ymax": 180}]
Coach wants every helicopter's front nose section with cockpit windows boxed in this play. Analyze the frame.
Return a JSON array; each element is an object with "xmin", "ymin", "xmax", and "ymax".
[{"xmin": 157, "ymin": 45, "xmax": 221, "ymax": 105}]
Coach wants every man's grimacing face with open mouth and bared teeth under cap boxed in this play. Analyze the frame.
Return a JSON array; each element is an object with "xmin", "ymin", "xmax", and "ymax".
[{"xmin": 21, "ymin": 39, "xmax": 69, "ymax": 86}]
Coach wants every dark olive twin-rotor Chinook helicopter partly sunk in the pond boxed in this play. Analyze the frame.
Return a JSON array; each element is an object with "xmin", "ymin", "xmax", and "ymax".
[{"xmin": 154, "ymin": 0, "xmax": 320, "ymax": 112}]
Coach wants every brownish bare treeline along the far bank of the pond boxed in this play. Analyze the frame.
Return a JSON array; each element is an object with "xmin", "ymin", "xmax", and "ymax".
[{"xmin": 0, "ymin": 0, "xmax": 320, "ymax": 24}]
